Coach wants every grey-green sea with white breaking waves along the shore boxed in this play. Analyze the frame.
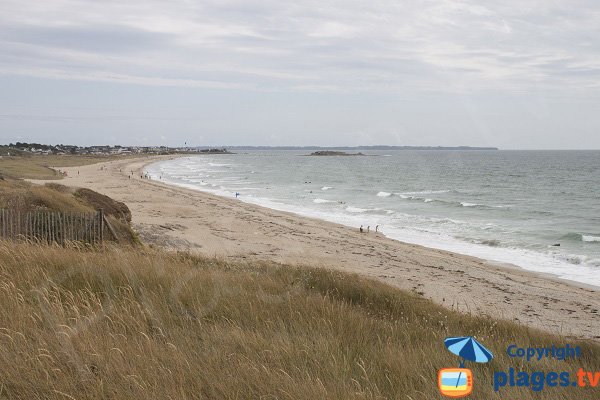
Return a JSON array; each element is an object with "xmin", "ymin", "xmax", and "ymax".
[{"xmin": 146, "ymin": 150, "xmax": 600, "ymax": 286}]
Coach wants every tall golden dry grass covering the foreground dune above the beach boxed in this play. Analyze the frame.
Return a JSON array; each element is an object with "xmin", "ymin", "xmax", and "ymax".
[{"xmin": 0, "ymin": 243, "xmax": 600, "ymax": 400}]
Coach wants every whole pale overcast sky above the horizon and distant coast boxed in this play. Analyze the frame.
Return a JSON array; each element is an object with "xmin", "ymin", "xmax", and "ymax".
[{"xmin": 0, "ymin": 0, "xmax": 600, "ymax": 149}]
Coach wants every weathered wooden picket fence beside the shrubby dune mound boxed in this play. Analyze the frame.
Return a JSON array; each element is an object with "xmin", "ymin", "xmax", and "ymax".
[{"xmin": 0, "ymin": 209, "xmax": 116, "ymax": 245}]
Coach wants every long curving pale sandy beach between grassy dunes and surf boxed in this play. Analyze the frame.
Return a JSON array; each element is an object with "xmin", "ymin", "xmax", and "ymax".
[{"xmin": 38, "ymin": 156, "xmax": 600, "ymax": 341}]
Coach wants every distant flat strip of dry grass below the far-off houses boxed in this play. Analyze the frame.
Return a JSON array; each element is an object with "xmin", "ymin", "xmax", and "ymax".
[{"xmin": 0, "ymin": 155, "xmax": 133, "ymax": 179}]
